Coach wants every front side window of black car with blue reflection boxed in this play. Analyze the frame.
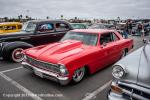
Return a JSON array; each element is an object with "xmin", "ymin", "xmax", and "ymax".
[{"xmin": 37, "ymin": 23, "xmax": 54, "ymax": 33}]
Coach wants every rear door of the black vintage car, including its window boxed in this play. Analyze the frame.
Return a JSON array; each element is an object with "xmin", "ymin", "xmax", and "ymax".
[{"xmin": 55, "ymin": 22, "xmax": 70, "ymax": 40}]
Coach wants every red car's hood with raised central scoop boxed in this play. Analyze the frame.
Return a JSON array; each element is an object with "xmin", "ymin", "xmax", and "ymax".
[{"xmin": 26, "ymin": 40, "xmax": 90, "ymax": 63}]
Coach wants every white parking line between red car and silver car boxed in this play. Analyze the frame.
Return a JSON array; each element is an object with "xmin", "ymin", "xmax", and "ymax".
[{"xmin": 82, "ymin": 80, "xmax": 111, "ymax": 100}]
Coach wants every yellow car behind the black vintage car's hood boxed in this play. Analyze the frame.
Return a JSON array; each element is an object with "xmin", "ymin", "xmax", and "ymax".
[{"xmin": 0, "ymin": 22, "xmax": 22, "ymax": 34}]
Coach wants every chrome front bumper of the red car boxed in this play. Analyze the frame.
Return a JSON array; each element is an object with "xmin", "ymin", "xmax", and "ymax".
[{"xmin": 21, "ymin": 62, "xmax": 70, "ymax": 85}]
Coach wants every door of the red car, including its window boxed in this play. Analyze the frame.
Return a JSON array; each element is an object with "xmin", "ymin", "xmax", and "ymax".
[{"xmin": 93, "ymin": 33, "xmax": 111, "ymax": 71}]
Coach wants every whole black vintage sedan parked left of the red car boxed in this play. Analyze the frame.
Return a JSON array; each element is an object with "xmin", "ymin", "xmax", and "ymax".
[{"xmin": 0, "ymin": 20, "xmax": 73, "ymax": 62}]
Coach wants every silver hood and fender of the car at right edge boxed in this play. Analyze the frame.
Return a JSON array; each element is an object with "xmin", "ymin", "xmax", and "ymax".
[{"xmin": 116, "ymin": 44, "xmax": 150, "ymax": 88}]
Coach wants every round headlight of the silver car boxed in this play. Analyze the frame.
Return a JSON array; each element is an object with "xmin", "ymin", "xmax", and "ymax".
[{"xmin": 112, "ymin": 65, "xmax": 125, "ymax": 79}]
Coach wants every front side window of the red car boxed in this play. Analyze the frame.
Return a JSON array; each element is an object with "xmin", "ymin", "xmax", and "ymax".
[{"xmin": 100, "ymin": 33, "xmax": 113, "ymax": 44}]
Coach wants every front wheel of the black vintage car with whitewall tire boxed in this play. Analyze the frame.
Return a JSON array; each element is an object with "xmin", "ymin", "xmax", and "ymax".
[{"xmin": 11, "ymin": 48, "xmax": 24, "ymax": 62}]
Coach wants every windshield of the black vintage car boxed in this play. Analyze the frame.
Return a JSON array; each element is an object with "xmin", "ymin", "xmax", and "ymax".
[{"xmin": 22, "ymin": 22, "xmax": 36, "ymax": 32}]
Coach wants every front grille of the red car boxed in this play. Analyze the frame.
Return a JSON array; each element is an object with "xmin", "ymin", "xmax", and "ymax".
[{"xmin": 26, "ymin": 56, "xmax": 59, "ymax": 73}]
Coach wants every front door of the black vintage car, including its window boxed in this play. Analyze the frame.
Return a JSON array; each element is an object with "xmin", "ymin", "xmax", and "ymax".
[{"xmin": 32, "ymin": 22, "xmax": 57, "ymax": 45}]
